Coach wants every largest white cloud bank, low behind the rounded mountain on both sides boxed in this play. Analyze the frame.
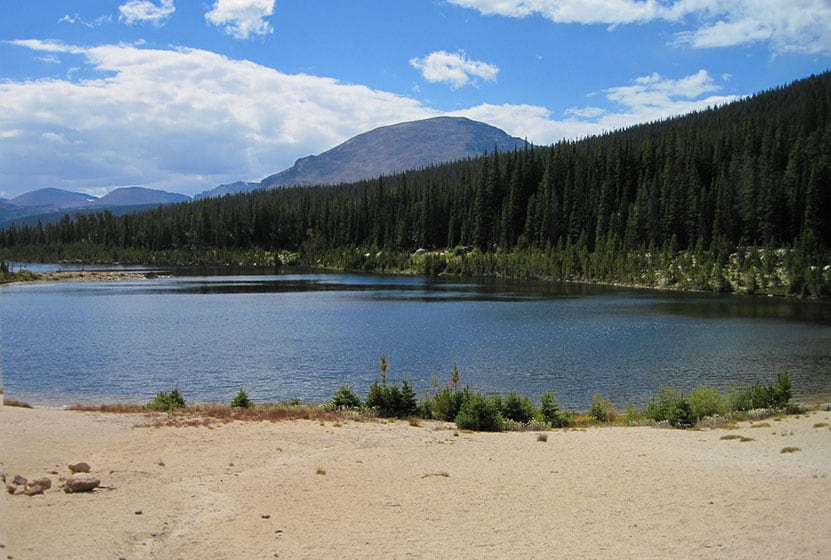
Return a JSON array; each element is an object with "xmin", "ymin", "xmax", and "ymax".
[{"xmin": 0, "ymin": 40, "xmax": 735, "ymax": 194}]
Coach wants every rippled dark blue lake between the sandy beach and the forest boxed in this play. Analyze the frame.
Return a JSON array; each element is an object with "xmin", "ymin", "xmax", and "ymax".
[{"xmin": 0, "ymin": 267, "xmax": 831, "ymax": 409}]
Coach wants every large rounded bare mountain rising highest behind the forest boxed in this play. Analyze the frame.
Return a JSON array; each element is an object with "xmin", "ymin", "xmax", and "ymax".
[{"xmin": 261, "ymin": 117, "xmax": 525, "ymax": 188}]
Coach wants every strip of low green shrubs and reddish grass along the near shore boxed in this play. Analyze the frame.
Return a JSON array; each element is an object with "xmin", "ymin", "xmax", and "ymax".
[{"xmin": 39, "ymin": 356, "xmax": 806, "ymax": 432}]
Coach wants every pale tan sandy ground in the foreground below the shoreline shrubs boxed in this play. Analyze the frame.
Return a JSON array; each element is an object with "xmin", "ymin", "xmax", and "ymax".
[{"xmin": 0, "ymin": 407, "xmax": 831, "ymax": 560}]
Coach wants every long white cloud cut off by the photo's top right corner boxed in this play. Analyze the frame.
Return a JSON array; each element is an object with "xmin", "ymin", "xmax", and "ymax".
[{"xmin": 448, "ymin": 0, "xmax": 831, "ymax": 55}]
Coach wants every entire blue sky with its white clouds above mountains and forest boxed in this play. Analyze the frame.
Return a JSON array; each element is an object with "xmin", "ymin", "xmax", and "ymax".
[{"xmin": 0, "ymin": 0, "xmax": 831, "ymax": 198}]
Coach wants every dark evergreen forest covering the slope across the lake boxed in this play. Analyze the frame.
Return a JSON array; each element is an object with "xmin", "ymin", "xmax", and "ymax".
[{"xmin": 0, "ymin": 72, "xmax": 831, "ymax": 297}]
